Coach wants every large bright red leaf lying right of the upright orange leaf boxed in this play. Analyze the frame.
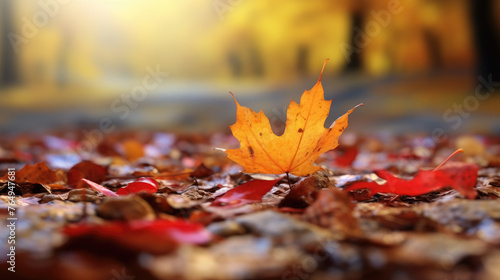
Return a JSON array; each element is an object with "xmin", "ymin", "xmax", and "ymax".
[{"xmin": 344, "ymin": 162, "xmax": 479, "ymax": 199}]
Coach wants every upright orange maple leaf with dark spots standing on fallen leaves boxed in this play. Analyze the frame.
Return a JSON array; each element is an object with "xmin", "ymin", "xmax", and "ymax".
[{"xmin": 223, "ymin": 60, "xmax": 363, "ymax": 176}]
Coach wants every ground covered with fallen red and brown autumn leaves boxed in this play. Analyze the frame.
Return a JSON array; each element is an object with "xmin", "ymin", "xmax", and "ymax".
[{"xmin": 0, "ymin": 132, "xmax": 500, "ymax": 280}]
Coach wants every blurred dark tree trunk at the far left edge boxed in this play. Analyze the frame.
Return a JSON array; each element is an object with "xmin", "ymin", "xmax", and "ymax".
[{"xmin": 0, "ymin": 0, "xmax": 19, "ymax": 87}]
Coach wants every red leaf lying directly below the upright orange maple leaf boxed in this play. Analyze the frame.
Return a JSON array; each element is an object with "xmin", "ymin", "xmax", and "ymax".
[{"xmin": 212, "ymin": 178, "xmax": 281, "ymax": 206}]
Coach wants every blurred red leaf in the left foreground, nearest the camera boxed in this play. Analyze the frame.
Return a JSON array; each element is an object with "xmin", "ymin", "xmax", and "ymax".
[{"xmin": 63, "ymin": 220, "xmax": 212, "ymax": 247}]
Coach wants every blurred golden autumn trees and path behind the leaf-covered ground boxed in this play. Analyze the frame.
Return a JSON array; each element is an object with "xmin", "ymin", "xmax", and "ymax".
[{"xmin": 0, "ymin": 0, "xmax": 500, "ymax": 134}]
